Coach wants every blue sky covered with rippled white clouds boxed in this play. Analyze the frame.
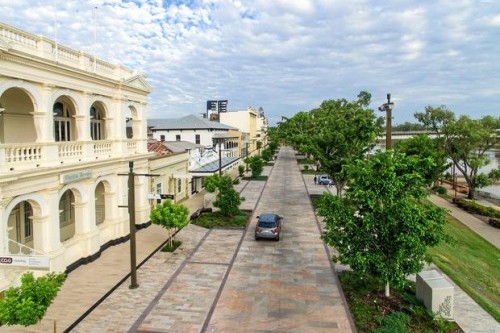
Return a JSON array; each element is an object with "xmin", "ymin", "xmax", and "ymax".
[{"xmin": 0, "ymin": 0, "xmax": 500, "ymax": 125}]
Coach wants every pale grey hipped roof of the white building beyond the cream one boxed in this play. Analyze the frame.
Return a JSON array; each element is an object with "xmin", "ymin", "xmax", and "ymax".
[{"xmin": 148, "ymin": 115, "xmax": 237, "ymax": 131}]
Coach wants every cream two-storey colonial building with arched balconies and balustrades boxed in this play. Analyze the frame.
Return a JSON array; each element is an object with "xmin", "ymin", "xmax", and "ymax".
[{"xmin": 0, "ymin": 23, "xmax": 151, "ymax": 290}]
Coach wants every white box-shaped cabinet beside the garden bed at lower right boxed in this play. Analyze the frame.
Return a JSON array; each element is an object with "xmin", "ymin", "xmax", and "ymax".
[{"xmin": 416, "ymin": 270, "xmax": 454, "ymax": 320}]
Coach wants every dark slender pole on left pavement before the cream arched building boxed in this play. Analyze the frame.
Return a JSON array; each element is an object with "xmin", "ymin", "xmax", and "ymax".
[{"xmin": 118, "ymin": 161, "xmax": 160, "ymax": 289}]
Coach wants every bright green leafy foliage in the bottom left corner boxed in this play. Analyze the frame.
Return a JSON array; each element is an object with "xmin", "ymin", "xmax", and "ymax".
[{"xmin": 0, "ymin": 272, "xmax": 66, "ymax": 326}]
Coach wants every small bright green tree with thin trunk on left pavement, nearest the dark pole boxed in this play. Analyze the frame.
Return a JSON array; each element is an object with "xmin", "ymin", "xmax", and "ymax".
[{"xmin": 149, "ymin": 200, "xmax": 189, "ymax": 246}]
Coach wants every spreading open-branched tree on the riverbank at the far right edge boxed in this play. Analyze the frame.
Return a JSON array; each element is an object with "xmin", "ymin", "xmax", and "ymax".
[{"xmin": 415, "ymin": 106, "xmax": 500, "ymax": 199}]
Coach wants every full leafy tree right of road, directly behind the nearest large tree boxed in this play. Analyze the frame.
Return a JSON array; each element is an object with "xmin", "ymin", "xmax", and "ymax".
[{"xmin": 308, "ymin": 91, "xmax": 383, "ymax": 196}]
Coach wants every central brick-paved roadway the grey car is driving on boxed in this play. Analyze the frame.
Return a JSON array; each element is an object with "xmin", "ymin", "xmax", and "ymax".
[{"xmin": 207, "ymin": 148, "xmax": 353, "ymax": 333}]
